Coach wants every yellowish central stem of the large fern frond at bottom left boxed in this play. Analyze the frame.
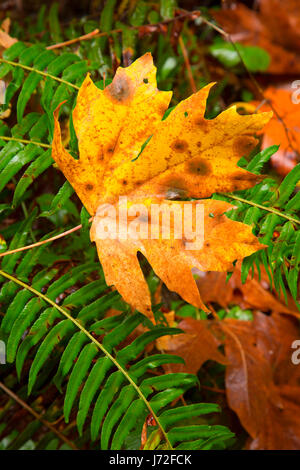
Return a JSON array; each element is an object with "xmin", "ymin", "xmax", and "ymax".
[{"xmin": 0, "ymin": 270, "xmax": 173, "ymax": 450}]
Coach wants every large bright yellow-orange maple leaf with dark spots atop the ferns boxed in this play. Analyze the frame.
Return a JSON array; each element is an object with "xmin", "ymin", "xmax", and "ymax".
[{"xmin": 52, "ymin": 53, "xmax": 272, "ymax": 317}]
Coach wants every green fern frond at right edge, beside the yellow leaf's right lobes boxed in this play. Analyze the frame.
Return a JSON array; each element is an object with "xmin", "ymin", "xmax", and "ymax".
[{"xmin": 214, "ymin": 146, "xmax": 300, "ymax": 308}]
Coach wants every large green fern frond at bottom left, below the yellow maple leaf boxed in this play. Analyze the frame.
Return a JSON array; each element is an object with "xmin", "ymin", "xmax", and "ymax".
[{"xmin": 0, "ymin": 266, "xmax": 233, "ymax": 449}]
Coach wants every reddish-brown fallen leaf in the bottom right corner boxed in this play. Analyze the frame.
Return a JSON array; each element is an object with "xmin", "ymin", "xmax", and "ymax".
[{"xmin": 223, "ymin": 313, "xmax": 300, "ymax": 450}]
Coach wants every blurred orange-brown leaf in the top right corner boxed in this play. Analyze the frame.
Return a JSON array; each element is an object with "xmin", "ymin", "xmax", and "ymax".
[{"xmin": 211, "ymin": 0, "xmax": 300, "ymax": 74}]
